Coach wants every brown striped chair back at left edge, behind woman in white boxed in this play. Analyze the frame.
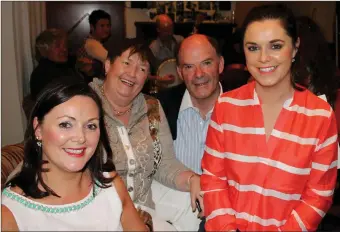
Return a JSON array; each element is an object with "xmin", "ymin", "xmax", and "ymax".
[{"xmin": 1, "ymin": 143, "xmax": 24, "ymax": 189}]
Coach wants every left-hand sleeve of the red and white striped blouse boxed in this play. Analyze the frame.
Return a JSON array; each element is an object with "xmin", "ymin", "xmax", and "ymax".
[{"xmin": 201, "ymin": 98, "xmax": 236, "ymax": 231}]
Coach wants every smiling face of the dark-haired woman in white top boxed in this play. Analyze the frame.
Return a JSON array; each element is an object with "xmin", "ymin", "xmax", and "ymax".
[{"xmin": 33, "ymin": 96, "xmax": 100, "ymax": 172}]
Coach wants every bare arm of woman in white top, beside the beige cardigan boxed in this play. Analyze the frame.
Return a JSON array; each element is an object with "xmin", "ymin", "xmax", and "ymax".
[{"xmin": 110, "ymin": 172, "xmax": 148, "ymax": 231}]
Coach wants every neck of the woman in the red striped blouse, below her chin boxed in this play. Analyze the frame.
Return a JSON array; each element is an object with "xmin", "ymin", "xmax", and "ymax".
[{"xmin": 255, "ymin": 75, "xmax": 294, "ymax": 105}]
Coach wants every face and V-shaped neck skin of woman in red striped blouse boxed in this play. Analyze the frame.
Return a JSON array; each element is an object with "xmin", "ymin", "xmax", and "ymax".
[{"xmin": 243, "ymin": 19, "xmax": 299, "ymax": 140}]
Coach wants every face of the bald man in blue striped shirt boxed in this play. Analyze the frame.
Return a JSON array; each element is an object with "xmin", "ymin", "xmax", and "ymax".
[{"xmin": 177, "ymin": 37, "xmax": 224, "ymax": 100}]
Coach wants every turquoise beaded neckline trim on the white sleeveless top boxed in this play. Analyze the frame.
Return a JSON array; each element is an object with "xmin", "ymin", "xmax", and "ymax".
[{"xmin": 2, "ymin": 184, "xmax": 101, "ymax": 213}]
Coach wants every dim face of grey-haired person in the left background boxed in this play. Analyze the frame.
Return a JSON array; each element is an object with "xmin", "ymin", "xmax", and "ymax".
[{"xmin": 46, "ymin": 38, "xmax": 68, "ymax": 63}]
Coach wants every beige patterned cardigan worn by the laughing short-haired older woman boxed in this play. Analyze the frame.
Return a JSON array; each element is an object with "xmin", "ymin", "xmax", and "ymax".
[{"xmin": 90, "ymin": 78, "xmax": 189, "ymax": 209}]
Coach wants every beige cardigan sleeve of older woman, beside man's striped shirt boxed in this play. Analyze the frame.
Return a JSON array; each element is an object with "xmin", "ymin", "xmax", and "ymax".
[{"xmin": 154, "ymin": 102, "xmax": 190, "ymax": 189}]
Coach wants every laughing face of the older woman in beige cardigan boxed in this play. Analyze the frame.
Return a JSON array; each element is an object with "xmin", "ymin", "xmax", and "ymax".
[{"xmin": 105, "ymin": 49, "xmax": 149, "ymax": 102}]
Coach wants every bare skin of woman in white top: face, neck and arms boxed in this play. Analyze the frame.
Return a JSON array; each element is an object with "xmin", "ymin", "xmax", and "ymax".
[{"xmin": 1, "ymin": 96, "xmax": 147, "ymax": 231}]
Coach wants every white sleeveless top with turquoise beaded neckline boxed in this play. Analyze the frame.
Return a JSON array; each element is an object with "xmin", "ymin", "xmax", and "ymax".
[{"xmin": 1, "ymin": 185, "xmax": 123, "ymax": 231}]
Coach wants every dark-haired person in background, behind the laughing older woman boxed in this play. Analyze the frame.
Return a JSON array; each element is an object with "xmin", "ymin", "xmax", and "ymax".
[{"xmin": 76, "ymin": 10, "xmax": 111, "ymax": 82}]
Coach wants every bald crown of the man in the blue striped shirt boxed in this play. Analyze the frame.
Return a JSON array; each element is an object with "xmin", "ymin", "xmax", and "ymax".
[{"xmin": 177, "ymin": 34, "xmax": 221, "ymax": 64}]
